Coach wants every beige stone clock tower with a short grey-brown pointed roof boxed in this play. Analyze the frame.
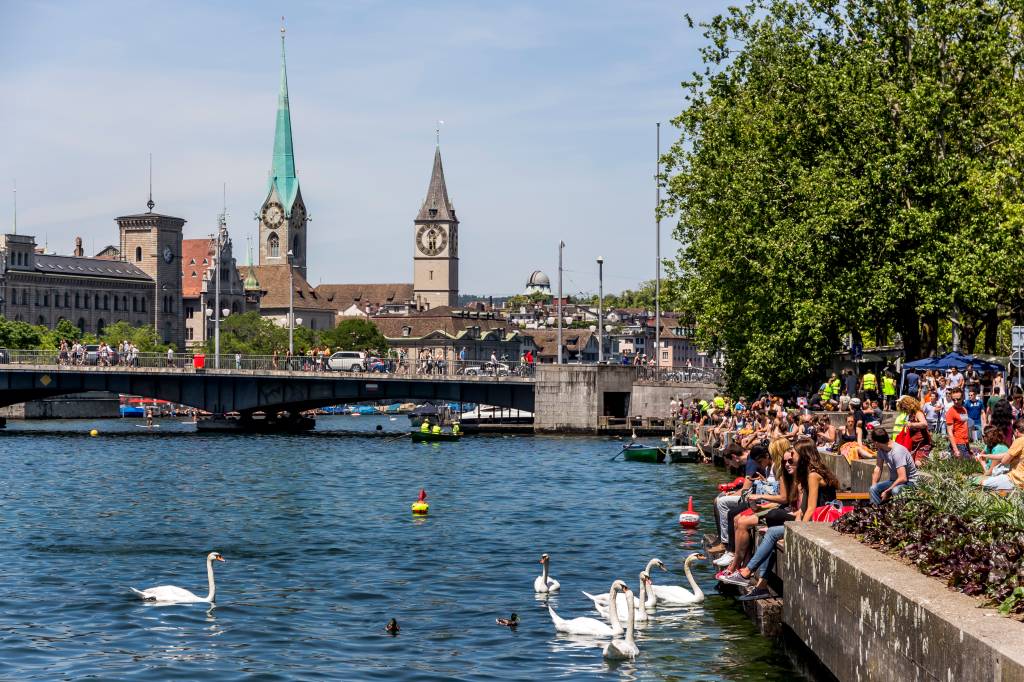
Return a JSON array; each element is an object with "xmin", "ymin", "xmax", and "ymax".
[{"xmin": 413, "ymin": 146, "xmax": 459, "ymax": 310}]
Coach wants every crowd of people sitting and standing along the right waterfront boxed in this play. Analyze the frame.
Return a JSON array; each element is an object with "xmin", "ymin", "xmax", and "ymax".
[{"xmin": 669, "ymin": 366, "xmax": 1024, "ymax": 599}]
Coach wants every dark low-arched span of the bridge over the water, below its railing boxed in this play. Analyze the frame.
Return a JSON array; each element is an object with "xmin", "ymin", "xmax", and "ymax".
[{"xmin": 0, "ymin": 365, "xmax": 535, "ymax": 414}]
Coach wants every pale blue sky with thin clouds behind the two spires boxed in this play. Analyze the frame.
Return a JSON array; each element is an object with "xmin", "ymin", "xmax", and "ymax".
[{"xmin": 0, "ymin": 0, "xmax": 724, "ymax": 295}]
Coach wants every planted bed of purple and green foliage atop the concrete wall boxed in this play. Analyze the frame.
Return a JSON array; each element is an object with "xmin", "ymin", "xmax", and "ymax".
[{"xmin": 836, "ymin": 457, "xmax": 1024, "ymax": 620}]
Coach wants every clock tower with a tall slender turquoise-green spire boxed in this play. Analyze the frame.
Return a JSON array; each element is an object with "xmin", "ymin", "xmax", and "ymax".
[{"xmin": 256, "ymin": 28, "xmax": 309, "ymax": 278}]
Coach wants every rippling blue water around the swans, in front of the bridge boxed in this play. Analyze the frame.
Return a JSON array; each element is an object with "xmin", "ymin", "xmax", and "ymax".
[{"xmin": 0, "ymin": 417, "xmax": 801, "ymax": 680}]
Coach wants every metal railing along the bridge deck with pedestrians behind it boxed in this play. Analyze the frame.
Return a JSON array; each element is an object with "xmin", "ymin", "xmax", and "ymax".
[{"xmin": 0, "ymin": 349, "xmax": 535, "ymax": 379}]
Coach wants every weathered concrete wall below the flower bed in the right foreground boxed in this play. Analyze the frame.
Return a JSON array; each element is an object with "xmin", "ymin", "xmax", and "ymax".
[{"xmin": 781, "ymin": 523, "xmax": 1024, "ymax": 682}]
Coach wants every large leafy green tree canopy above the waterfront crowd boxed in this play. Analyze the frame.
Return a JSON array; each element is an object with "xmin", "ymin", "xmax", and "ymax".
[{"xmin": 660, "ymin": 0, "xmax": 1024, "ymax": 391}]
